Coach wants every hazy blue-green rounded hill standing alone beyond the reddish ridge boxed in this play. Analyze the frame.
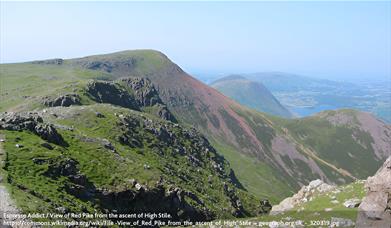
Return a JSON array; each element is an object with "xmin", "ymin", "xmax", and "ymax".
[{"xmin": 210, "ymin": 75, "xmax": 292, "ymax": 118}]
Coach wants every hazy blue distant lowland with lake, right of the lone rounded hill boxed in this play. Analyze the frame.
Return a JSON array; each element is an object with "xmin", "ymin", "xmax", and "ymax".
[{"xmin": 242, "ymin": 72, "xmax": 391, "ymax": 123}]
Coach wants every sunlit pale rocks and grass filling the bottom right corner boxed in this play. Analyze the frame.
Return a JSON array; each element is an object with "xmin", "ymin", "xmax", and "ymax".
[{"xmin": 251, "ymin": 157, "xmax": 391, "ymax": 228}]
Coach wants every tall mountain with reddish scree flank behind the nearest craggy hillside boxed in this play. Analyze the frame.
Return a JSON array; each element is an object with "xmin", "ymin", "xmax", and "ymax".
[{"xmin": 0, "ymin": 50, "xmax": 391, "ymax": 206}]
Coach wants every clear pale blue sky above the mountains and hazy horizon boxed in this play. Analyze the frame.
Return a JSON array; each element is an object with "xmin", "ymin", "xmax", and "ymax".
[{"xmin": 0, "ymin": 1, "xmax": 391, "ymax": 80}]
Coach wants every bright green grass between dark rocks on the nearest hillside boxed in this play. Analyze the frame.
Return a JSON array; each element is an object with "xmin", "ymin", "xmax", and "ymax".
[{"xmin": 2, "ymin": 105, "xmax": 258, "ymax": 218}]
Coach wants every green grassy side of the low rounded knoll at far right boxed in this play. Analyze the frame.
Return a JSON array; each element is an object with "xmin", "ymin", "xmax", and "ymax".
[{"xmin": 282, "ymin": 116, "xmax": 382, "ymax": 179}]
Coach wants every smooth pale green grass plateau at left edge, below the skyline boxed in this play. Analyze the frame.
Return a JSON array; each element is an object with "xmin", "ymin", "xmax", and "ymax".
[{"xmin": 0, "ymin": 63, "xmax": 106, "ymax": 111}]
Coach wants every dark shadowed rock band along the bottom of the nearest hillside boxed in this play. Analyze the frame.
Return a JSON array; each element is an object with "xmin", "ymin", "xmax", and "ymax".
[{"xmin": 41, "ymin": 157, "xmax": 214, "ymax": 221}]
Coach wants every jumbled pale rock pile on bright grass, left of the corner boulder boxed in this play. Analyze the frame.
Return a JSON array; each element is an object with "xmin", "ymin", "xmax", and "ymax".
[{"xmin": 270, "ymin": 179, "xmax": 335, "ymax": 215}]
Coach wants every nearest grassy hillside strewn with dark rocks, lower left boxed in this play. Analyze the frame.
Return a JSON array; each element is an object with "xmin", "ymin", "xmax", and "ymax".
[{"xmin": 2, "ymin": 104, "xmax": 257, "ymax": 220}]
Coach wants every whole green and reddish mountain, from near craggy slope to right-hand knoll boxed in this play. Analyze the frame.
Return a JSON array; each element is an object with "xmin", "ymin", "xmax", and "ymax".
[{"xmin": 0, "ymin": 50, "xmax": 391, "ymax": 220}]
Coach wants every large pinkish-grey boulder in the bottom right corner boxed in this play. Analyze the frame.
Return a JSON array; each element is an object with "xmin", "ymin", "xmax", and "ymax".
[{"xmin": 356, "ymin": 157, "xmax": 391, "ymax": 228}]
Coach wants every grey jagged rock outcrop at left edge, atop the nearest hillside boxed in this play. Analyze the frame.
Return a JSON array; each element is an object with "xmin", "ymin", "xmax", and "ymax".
[{"xmin": 0, "ymin": 112, "xmax": 67, "ymax": 146}]
